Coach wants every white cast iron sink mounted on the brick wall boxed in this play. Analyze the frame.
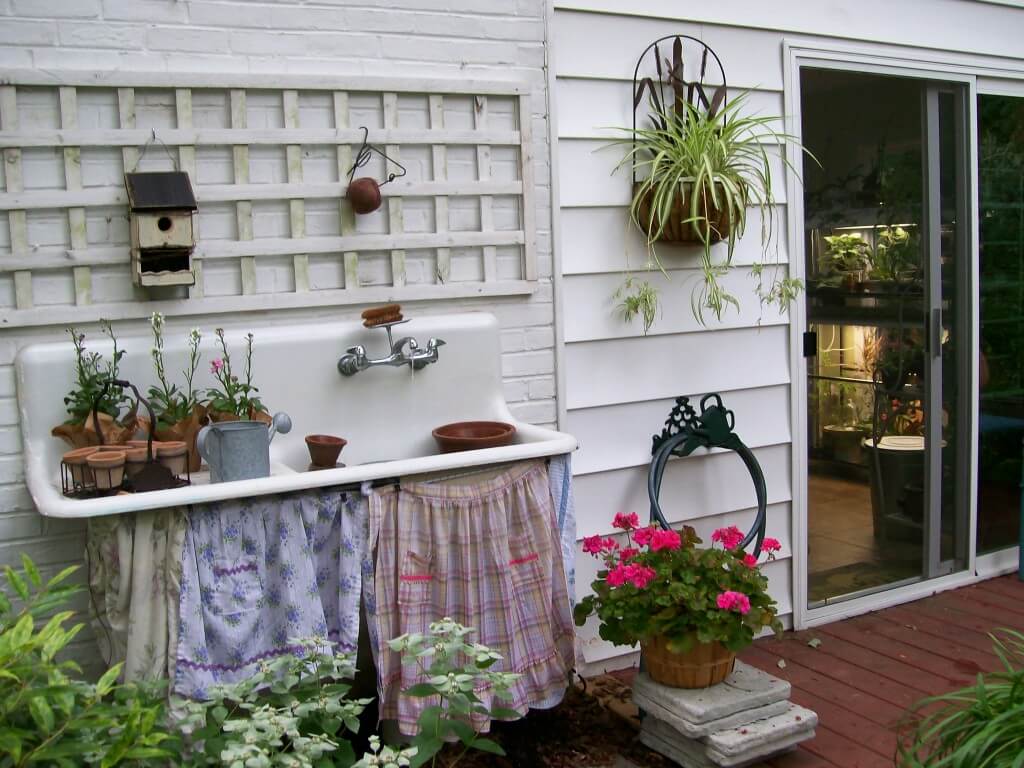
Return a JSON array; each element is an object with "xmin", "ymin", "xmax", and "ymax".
[{"xmin": 15, "ymin": 312, "xmax": 577, "ymax": 517}]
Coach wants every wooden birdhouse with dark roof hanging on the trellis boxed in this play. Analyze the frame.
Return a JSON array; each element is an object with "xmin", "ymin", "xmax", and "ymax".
[{"xmin": 125, "ymin": 171, "xmax": 199, "ymax": 287}]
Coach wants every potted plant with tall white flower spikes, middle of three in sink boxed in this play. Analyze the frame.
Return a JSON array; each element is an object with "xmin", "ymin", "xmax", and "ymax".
[{"xmin": 147, "ymin": 312, "xmax": 206, "ymax": 472}]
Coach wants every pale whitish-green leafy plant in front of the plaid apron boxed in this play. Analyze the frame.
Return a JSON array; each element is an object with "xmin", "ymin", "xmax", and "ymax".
[{"xmin": 388, "ymin": 617, "xmax": 521, "ymax": 768}]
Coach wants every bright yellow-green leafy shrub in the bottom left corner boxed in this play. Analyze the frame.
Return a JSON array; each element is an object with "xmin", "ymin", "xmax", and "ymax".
[{"xmin": 0, "ymin": 555, "xmax": 177, "ymax": 768}]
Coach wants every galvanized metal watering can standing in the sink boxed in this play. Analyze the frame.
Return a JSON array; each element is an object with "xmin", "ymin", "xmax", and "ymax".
[{"xmin": 196, "ymin": 413, "xmax": 292, "ymax": 482}]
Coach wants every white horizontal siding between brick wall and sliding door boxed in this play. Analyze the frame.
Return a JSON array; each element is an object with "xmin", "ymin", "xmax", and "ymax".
[{"xmin": 553, "ymin": 2, "xmax": 793, "ymax": 664}]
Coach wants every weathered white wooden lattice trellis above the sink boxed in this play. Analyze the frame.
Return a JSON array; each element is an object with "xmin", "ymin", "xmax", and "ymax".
[{"xmin": 0, "ymin": 72, "xmax": 537, "ymax": 328}]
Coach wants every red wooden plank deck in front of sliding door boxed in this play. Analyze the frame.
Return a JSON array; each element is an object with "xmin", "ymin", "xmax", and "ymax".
[{"xmin": 740, "ymin": 575, "xmax": 1024, "ymax": 768}]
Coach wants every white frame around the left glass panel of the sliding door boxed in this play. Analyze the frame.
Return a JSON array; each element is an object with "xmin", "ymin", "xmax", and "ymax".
[{"xmin": 783, "ymin": 40, "xmax": 983, "ymax": 629}]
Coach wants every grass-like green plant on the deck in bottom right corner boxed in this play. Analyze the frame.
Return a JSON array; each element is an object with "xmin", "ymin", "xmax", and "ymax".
[{"xmin": 897, "ymin": 629, "xmax": 1024, "ymax": 768}]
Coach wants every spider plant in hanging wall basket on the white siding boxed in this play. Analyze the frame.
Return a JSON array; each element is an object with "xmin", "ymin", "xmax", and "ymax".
[{"xmin": 612, "ymin": 87, "xmax": 806, "ymax": 332}]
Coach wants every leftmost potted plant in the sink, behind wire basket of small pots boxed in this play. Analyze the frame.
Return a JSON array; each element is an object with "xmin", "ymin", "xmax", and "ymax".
[{"xmin": 51, "ymin": 321, "xmax": 148, "ymax": 449}]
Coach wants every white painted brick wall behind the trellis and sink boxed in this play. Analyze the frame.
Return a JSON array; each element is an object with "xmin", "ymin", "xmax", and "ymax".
[{"xmin": 0, "ymin": 0, "xmax": 556, "ymax": 663}]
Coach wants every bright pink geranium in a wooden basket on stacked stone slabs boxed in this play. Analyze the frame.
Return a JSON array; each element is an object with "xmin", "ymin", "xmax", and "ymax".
[{"xmin": 574, "ymin": 513, "xmax": 782, "ymax": 688}]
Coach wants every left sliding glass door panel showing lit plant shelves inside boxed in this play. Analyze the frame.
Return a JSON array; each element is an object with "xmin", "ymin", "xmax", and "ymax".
[{"xmin": 800, "ymin": 68, "xmax": 971, "ymax": 607}]
